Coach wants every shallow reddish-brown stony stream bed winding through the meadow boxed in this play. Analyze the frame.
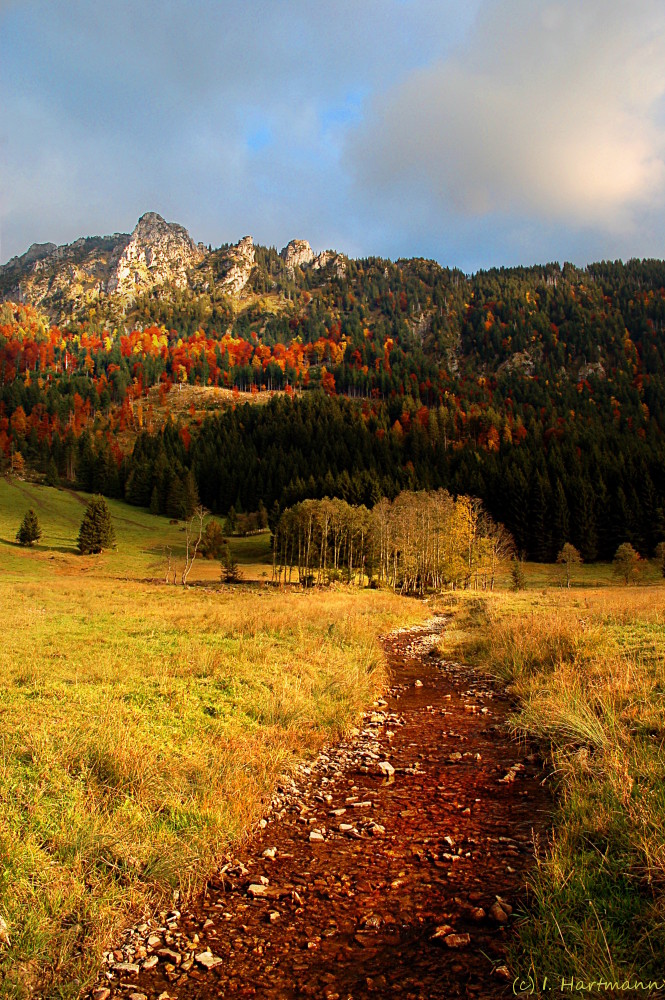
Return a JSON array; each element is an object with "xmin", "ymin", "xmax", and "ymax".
[{"xmin": 93, "ymin": 618, "xmax": 550, "ymax": 1000}]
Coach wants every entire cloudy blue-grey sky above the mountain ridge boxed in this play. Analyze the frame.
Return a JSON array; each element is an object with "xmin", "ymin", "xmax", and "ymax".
[{"xmin": 0, "ymin": 0, "xmax": 665, "ymax": 272}]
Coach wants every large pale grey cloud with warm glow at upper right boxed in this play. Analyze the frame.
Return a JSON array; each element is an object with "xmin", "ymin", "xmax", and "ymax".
[{"xmin": 347, "ymin": 0, "xmax": 665, "ymax": 233}]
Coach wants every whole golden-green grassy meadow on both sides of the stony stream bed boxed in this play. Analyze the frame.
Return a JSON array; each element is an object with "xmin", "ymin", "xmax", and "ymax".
[{"xmin": 0, "ymin": 480, "xmax": 665, "ymax": 1000}]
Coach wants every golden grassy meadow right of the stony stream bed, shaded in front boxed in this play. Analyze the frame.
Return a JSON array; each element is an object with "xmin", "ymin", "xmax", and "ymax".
[{"xmin": 444, "ymin": 584, "xmax": 665, "ymax": 995}]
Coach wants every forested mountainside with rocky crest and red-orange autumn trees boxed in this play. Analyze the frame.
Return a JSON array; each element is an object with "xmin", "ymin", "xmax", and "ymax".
[{"xmin": 0, "ymin": 213, "xmax": 665, "ymax": 561}]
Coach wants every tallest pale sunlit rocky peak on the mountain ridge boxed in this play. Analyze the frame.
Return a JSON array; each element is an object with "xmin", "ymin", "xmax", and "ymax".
[{"xmin": 106, "ymin": 212, "xmax": 204, "ymax": 299}]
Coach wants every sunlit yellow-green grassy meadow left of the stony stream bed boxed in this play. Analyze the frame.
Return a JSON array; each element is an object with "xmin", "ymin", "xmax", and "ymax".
[{"xmin": 0, "ymin": 480, "xmax": 426, "ymax": 998}]
